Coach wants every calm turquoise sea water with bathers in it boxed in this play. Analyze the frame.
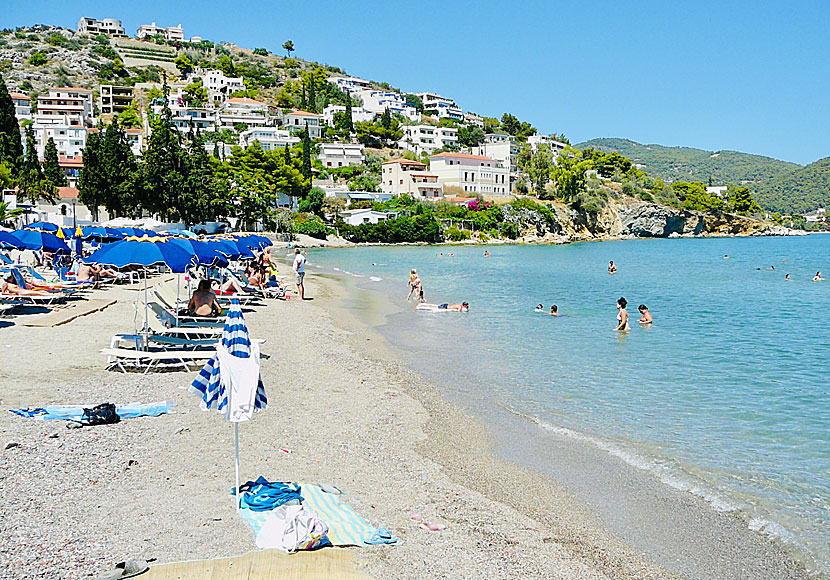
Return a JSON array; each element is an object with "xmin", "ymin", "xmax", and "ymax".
[{"xmin": 309, "ymin": 235, "xmax": 830, "ymax": 572}]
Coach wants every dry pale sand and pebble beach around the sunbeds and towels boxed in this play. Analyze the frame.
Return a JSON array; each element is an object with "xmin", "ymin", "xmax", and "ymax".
[{"xmin": 0, "ymin": 267, "xmax": 820, "ymax": 579}]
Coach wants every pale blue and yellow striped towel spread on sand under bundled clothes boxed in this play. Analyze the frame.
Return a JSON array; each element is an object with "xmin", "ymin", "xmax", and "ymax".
[{"xmin": 240, "ymin": 483, "xmax": 388, "ymax": 546}]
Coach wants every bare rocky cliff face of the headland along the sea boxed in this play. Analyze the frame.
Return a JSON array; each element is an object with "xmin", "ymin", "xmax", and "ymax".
[{"xmin": 524, "ymin": 198, "xmax": 796, "ymax": 243}]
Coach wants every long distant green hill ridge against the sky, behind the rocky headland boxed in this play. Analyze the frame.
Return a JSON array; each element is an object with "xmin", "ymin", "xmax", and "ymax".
[{"xmin": 576, "ymin": 138, "xmax": 800, "ymax": 189}]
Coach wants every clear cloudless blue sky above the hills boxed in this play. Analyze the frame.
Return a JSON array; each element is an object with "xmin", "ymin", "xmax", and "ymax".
[{"xmin": 6, "ymin": 0, "xmax": 830, "ymax": 164}]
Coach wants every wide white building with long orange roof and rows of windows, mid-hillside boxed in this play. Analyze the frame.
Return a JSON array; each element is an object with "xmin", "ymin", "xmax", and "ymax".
[{"xmin": 429, "ymin": 153, "xmax": 510, "ymax": 195}]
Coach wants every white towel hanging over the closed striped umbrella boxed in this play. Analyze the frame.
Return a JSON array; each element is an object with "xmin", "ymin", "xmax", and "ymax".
[{"xmin": 216, "ymin": 342, "xmax": 259, "ymax": 423}]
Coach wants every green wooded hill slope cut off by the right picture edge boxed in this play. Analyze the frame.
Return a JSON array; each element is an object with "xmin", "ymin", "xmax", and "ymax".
[{"xmin": 755, "ymin": 157, "xmax": 830, "ymax": 213}]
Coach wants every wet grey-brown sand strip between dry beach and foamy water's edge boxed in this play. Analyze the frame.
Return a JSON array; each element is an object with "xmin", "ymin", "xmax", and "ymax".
[{"xmin": 314, "ymin": 266, "xmax": 819, "ymax": 578}]
